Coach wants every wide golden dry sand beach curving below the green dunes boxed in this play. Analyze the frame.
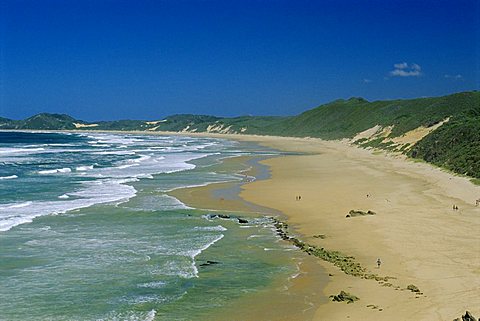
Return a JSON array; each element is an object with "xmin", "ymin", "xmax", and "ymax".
[{"xmin": 171, "ymin": 131, "xmax": 480, "ymax": 320}]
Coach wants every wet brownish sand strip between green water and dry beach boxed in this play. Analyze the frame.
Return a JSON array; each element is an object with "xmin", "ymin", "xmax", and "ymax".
[{"xmin": 172, "ymin": 155, "xmax": 328, "ymax": 321}]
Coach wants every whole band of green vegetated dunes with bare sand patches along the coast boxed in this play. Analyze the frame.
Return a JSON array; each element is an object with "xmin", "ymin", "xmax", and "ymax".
[{"xmin": 0, "ymin": 91, "xmax": 480, "ymax": 179}]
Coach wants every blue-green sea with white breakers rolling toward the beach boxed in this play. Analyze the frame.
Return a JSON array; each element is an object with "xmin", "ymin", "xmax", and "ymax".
[{"xmin": 0, "ymin": 132, "xmax": 296, "ymax": 320}]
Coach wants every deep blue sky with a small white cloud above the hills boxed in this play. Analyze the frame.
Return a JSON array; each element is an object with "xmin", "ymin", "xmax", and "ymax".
[{"xmin": 0, "ymin": 0, "xmax": 480, "ymax": 121}]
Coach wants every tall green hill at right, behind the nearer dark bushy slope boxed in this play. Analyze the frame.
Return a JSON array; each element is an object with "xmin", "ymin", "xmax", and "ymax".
[{"xmin": 272, "ymin": 92, "xmax": 480, "ymax": 139}]
